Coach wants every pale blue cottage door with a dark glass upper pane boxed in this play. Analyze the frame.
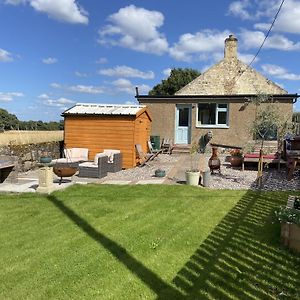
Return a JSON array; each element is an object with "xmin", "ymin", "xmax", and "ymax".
[{"xmin": 175, "ymin": 104, "xmax": 191, "ymax": 144}]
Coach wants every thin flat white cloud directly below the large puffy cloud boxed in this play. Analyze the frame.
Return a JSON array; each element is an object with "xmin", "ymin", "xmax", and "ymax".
[{"xmin": 98, "ymin": 66, "xmax": 154, "ymax": 79}]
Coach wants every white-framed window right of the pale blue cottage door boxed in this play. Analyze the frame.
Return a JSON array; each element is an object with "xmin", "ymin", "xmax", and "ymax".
[{"xmin": 197, "ymin": 103, "xmax": 228, "ymax": 127}]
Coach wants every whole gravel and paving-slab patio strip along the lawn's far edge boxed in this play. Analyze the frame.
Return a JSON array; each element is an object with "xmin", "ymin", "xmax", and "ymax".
[{"xmin": 0, "ymin": 154, "xmax": 300, "ymax": 192}]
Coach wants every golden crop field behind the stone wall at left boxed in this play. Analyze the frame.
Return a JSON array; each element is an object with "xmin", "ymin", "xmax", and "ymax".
[{"xmin": 0, "ymin": 130, "xmax": 64, "ymax": 146}]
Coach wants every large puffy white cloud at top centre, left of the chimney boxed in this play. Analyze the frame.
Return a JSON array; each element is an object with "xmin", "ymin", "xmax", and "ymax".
[{"xmin": 99, "ymin": 5, "xmax": 168, "ymax": 55}]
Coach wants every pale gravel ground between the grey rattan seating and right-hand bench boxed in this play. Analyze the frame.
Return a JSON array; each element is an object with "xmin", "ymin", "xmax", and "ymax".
[{"xmin": 105, "ymin": 154, "xmax": 300, "ymax": 191}]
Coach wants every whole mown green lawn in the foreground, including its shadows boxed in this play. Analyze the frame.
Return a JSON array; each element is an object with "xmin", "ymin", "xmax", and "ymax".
[{"xmin": 0, "ymin": 185, "xmax": 300, "ymax": 300}]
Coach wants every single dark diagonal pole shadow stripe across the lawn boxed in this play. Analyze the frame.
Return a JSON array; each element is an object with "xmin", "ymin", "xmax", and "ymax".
[{"xmin": 47, "ymin": 195, "xmax": 182, "ymax": 299}]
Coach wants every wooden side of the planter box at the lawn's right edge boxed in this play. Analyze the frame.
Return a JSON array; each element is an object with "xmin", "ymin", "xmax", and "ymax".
[{"xmin": 281, "ymin": 223, "xmax": 300, "ymax": 253}]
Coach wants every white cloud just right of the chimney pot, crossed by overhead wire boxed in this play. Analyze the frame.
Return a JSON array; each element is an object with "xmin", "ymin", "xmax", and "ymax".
[{"xmin": 240, "ymin": 30, "xmax": 300, "ymax": 51}]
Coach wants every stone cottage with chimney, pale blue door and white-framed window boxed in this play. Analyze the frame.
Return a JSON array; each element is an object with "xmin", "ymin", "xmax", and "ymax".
[{"xmin": 136, "ymin": 35, "xmax": 298, "ymax": 146}]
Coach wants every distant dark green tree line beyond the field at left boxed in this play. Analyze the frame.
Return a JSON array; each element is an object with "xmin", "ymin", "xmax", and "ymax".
[{"xmin": 0, "ymin": 108, "xmax": 64, "ymax": 132}]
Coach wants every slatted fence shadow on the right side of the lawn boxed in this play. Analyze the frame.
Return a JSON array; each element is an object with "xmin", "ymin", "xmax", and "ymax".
[{"xmin": 157, "ymin": 191, "xmax": 300, "ymax": 300}]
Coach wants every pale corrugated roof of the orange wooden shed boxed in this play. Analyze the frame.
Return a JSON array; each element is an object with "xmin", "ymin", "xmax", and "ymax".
[{"xmin": 62, "ymin": 103, "xmax": 146, "ymax": 116}]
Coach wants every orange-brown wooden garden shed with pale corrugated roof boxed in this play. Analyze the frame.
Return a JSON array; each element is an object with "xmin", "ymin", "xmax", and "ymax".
[{"xmin": 62, "ymin": 103, "xmax": 152, "ymax": 168}]
